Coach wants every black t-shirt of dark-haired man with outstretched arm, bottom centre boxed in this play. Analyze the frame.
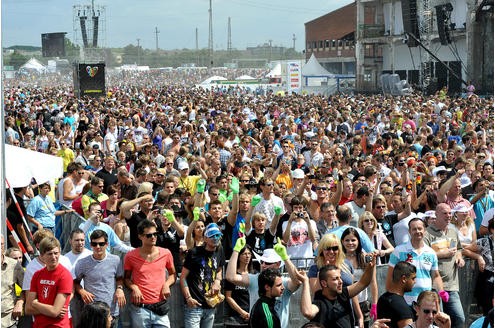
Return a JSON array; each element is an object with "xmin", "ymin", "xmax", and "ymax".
[{"xmin": 311, "ymin": 287, "xmax": 354, "ymax": 328}]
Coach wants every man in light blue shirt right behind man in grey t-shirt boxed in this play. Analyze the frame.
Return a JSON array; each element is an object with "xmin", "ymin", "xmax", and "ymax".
[{"xmin": 79, "ymin": 202, "xmax": 134, "ymax": 253}]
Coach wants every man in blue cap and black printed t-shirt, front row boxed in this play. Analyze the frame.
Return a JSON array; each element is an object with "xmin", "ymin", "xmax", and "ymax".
[{"xmin": 180, "ymin": 223, "xmax": 225, "ymax": 328}]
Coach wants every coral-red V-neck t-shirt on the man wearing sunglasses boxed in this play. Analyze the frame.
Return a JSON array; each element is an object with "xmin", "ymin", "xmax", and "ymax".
[{"xmin": 124, "ymin": 247, "xmax": 174, "ymax": 304}]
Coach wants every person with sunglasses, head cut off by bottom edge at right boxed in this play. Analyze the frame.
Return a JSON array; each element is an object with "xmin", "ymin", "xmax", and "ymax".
[{"xmin": 406, "ymin": 290, "xmax": 451, "ymax": 328}]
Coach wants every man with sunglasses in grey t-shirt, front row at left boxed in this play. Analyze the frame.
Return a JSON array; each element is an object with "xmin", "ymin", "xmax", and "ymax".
[{"xmin": 73, "ymin": 230, "xmax": 126, "ymax": 327}]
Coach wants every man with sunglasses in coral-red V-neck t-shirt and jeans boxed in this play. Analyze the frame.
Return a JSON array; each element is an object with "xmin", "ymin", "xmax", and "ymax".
[{"xmin": 124, "ymin": 220, "xmax": 177, "ymax": 328}]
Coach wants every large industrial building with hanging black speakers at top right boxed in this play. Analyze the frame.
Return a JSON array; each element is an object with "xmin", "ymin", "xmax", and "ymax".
[{"xmin": 305, "ymin": 0, "xmax": 493, "ymax": 93}]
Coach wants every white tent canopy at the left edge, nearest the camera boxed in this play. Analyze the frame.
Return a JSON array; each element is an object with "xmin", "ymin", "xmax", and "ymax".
[{"xmin": 5, "ymin": 145, "xmax": 64, "ymax": 188}]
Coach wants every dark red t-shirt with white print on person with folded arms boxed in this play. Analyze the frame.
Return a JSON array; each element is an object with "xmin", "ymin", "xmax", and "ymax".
[{"xmin": 29, "ymin": 264, "xmax": 73, "ymax": 328}]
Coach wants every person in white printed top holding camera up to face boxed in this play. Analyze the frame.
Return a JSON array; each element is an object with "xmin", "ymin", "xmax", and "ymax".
[{"xmin": 282, "ymin": 196, "xmax": 317, "ymax": 268}]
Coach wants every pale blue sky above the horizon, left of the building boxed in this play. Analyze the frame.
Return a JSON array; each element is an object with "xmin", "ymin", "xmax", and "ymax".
[{"xmin": 2, "ymin": 0, "xmax": 352, "ymax": 51}]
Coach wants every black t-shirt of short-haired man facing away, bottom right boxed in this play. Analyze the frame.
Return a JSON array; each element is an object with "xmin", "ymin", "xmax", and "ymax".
[{"xmin": 376, "ymin": 292, "xmax": 413, "ymax": 328}]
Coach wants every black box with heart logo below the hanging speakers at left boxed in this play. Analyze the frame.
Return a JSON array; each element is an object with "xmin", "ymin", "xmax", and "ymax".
[{"xmin": 74, "ymin": 63, "xmax": 105, "ymax": 97}]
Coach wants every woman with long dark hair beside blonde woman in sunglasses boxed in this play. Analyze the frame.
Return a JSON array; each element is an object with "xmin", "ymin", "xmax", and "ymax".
[{"xmin": 340, "ymin": 228, "xmax": 380, "ymax": 328}]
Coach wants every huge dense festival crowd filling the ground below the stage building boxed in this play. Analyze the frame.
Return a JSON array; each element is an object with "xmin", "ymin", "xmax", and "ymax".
[{"xmin": 2, "ymin": 71, "xmax": 495, "ymax": 328}]
